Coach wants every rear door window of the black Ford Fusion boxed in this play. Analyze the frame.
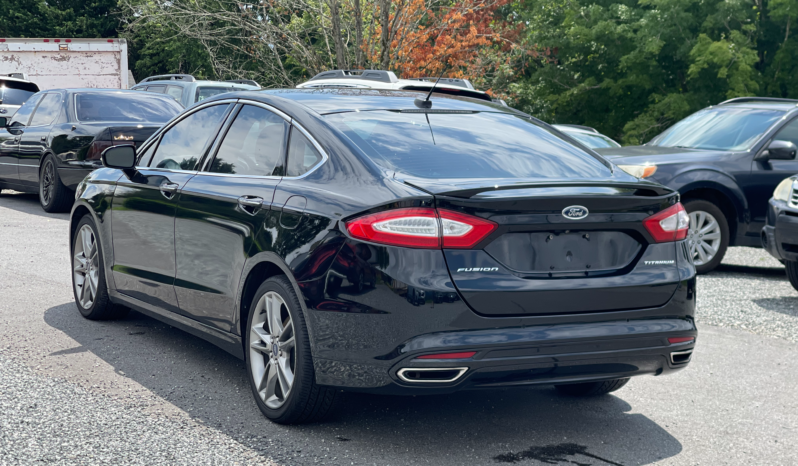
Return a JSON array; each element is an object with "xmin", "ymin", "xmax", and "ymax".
[{"xmin": 210, "ymin": 105, "xmax": 288, "ymax": 176}]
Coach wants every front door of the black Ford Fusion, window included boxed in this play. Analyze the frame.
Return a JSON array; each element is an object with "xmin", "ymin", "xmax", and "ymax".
[{"xmin": 111, "ymin": 102, "xmax": 231, "ymax": 312}]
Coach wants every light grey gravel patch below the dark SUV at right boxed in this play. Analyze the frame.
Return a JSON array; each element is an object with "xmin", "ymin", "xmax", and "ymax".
[{"xmin": 696, "ymin": 248, "xmax": 798, "ymax": 342}]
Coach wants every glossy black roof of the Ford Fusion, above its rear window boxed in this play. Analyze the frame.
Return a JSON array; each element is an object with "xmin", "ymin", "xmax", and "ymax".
[{"xmin": 228, "ymin": 88, "xmax": 522, "ymax": 115}]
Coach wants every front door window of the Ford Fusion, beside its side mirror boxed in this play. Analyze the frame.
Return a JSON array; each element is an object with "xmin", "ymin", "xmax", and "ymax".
[{"xmin": 149, "ymin": 104, "xmax": 229, "ymax": 170}]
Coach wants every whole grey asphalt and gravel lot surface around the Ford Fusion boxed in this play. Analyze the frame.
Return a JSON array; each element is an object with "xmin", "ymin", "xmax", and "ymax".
[{"xmin": 0, "ymin": 191, "xmax": 798, "ymax": 466}]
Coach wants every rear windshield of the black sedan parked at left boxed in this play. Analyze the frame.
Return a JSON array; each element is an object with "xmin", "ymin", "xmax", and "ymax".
[{"xmin": 75, "ymin": 92, "xmax": 183, "ymax": 123}]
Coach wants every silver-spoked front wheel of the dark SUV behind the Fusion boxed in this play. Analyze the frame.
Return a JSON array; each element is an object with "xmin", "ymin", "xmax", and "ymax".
[{"xmin": 684, "ymin": 199, "xmax": 729, "ymax": 273}]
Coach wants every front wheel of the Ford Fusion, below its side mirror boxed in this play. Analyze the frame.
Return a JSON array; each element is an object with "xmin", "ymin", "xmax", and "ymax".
[{"xmin": 72, "ymin": 215, "xmax": 129, "ymax": 320}]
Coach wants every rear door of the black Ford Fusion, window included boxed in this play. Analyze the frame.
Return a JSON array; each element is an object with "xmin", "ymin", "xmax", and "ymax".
[{"xmin": 175, "ymin": 104, "xmax": 289, "ymax": 331}]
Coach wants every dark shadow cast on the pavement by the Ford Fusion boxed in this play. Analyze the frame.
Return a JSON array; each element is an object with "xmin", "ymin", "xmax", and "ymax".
[{"xmin": 44, "ymin": 303, "xmax": 682, "ymax": 465}]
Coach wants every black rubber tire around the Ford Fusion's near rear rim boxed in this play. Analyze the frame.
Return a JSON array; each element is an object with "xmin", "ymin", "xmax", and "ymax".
[{"xmin": 244, "ymin": 276, "xmax": 338, "ymax": 424}]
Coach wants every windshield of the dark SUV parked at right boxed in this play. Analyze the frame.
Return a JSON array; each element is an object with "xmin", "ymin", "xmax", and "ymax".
[{"xmin": 648, "ymin": 107, "xmax": 785, "ymax": 151}]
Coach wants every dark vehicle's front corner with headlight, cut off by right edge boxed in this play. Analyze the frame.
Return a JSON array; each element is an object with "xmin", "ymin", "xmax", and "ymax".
[{"xmin": 762, "ymin": 175, "xmax": 798, "ymax": 290}]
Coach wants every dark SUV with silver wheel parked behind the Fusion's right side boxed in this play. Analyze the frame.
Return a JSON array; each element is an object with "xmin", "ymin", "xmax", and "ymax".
[{"xmin": 597, "ymin": 97, "xmax": 798, "ymax": 273}]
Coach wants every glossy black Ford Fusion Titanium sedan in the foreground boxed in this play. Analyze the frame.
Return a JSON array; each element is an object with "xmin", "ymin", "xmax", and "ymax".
[{"xmin": 71, "ymin": 89, "xmax": 696, "ymax": 423}]
